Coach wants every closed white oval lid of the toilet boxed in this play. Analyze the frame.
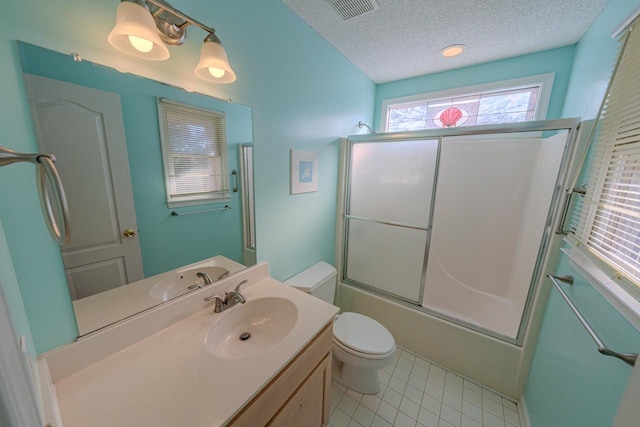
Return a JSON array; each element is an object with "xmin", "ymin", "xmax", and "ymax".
[{"xmin": 333, "ymin": 313, "xmax": 395, "ymax": 354}]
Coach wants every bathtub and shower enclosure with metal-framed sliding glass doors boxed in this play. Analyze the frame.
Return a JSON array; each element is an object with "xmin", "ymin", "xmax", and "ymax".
[{"xmin": 336, "ymin": 119, "xmax": 577, "ymax": 399}]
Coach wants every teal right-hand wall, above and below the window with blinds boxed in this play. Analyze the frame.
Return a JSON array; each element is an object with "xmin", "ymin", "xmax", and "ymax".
[{"xmin": 525, "ymin": 0, "xmax": 640, "ymax": 427}]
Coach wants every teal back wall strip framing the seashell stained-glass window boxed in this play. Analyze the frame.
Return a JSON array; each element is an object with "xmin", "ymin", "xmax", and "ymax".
[{"xmin": 374, "ymin": 46, "xmax": 576, "ymax": 129}]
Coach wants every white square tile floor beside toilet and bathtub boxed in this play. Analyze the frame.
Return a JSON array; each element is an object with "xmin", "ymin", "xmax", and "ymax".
[{"xmin": 329, "ymin": 348, "xmax": 520, "ymax": 427}]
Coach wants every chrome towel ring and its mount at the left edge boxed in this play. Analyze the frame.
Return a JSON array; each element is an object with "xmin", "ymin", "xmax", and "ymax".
[{"xmin": 0, "ymin": 146, "xmax": 71, "ymax": 245}]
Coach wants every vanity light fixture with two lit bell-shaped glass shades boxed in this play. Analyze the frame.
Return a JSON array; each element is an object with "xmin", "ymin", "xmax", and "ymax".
[{"xmin": 108, "ymin": 0, "xmax": 236, "ymax": 83}]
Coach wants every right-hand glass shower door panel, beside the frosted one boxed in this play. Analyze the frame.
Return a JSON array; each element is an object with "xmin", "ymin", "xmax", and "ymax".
[{"xmin": 422, "ymin": 131, "xmax": 568, "ymax": 340}]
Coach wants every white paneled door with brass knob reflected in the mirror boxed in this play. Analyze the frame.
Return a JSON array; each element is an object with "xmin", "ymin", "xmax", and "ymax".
[{"xmin": 25, "ymin": 75, "xmax": 143, "ymax": 300}]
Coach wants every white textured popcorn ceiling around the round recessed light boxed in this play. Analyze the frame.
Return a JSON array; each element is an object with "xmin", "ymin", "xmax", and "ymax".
[{"xmin": 283, "ymin": 0, "xmax": 608, "ymax": 83}]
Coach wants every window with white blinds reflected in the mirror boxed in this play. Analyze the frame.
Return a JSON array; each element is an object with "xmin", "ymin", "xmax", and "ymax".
[{"xmin": 158, "ymin": 98, "xmax": 229, "ymax": 207}]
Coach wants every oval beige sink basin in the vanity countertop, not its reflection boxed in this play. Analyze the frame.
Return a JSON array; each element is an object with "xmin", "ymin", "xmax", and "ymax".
[{"xmin": 205, "ymin": 297, "xmax": 298, "ymax": 359}]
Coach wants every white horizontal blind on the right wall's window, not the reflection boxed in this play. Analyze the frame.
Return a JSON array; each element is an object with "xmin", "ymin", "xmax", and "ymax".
[{"xmin": 574, "ymin": 19, "xmax": 640, "ymax": 285}]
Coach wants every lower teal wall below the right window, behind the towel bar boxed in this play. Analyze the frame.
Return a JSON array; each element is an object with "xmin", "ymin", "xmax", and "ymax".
[{"xmin": 525, "ymin": 255, "xmax": 640, "ymax": 427}]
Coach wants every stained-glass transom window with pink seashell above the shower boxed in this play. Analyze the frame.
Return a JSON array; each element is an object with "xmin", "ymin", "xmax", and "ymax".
[{"xmin": 382, "ymin": 74, "xmax": 553, "ymax": 132}]
